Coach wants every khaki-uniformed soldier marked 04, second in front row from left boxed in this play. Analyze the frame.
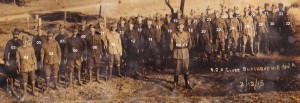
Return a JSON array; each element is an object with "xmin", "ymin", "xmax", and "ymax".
[{"xmin": 41, "ymin": 31, "xmax": 61, "ymax": 92}]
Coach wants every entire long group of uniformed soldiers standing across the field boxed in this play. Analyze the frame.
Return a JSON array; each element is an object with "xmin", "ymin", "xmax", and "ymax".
[{"xmin": 4, "ymin": 3, "xmax": 295, "ymax": 100}]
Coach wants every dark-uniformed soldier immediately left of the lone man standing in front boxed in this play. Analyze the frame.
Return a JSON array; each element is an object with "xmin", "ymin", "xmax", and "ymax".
[{"xmin": 161, "ymin": 14, "xmax": 176, "ymax": 68}]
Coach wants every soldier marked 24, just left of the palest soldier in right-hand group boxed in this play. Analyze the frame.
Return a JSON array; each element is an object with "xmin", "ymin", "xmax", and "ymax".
[{"xmin": 227, "ymin": 9, "xmax": 241, "ymax": 56}]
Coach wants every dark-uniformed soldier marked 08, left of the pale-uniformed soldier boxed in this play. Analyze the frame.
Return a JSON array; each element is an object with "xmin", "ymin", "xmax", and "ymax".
[{"xmin": 86, "ymin": 25, "xmax": 105, "ymax": 83}]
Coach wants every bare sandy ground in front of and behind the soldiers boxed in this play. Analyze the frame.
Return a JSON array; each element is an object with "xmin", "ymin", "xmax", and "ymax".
[{"xmin": 0, "ymin": 0, "xmax": 300, "ymax": 103}]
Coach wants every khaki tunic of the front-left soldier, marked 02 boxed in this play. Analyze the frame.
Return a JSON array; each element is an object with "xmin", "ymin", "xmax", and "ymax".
[{"xmin": 16, "ymin": 46, "xmax": 37, "ymax": 72}]
